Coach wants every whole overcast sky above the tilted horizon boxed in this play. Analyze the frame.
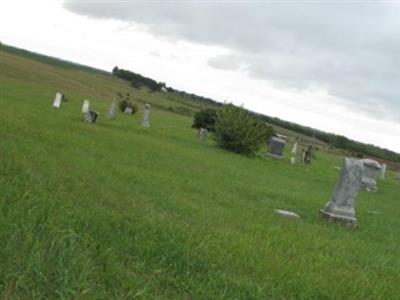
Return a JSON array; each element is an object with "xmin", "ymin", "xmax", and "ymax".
[{"xmin": 0, "ymin": 0, "xmax": 400, "ymax": 152}]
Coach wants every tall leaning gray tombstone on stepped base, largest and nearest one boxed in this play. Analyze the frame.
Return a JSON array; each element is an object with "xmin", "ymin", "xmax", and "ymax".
[{"xmin": 320, "ymin": 158, "xmax": 363, "ymax": 226}]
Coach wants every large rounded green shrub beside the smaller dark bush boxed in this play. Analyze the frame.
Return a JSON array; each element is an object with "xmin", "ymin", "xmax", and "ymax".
[{"xmin": 215, "ymin": 104, "xmax": 271, "ymax": 154}]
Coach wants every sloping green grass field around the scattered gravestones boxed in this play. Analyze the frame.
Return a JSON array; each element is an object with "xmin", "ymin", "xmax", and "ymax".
[{"xmin": 0, "ymin": 45, "xmax": 400, "ymax": 299}]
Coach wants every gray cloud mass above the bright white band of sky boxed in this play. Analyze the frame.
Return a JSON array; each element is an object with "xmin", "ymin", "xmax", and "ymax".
[{"xmin": 64, "ymin": 1, "xmax": 400, "ymax": 120}]
